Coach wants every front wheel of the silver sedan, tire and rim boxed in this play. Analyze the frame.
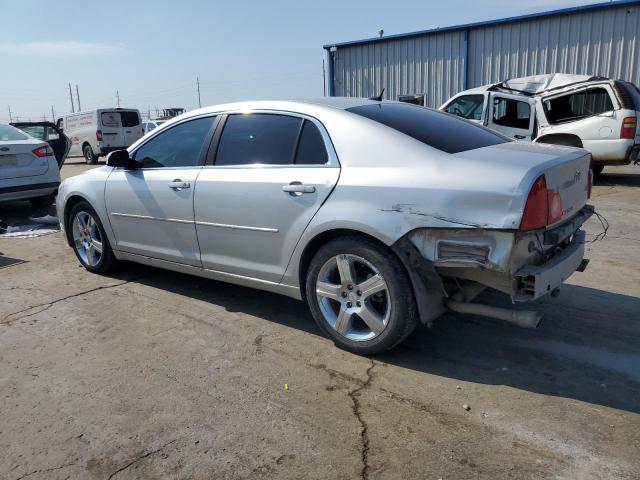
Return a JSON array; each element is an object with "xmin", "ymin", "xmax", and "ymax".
[{"xmin": 66, "ymin": 202, "xmax": 118, "ymax": 274}]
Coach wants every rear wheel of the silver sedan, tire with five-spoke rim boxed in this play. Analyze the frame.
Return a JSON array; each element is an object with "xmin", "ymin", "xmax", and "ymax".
[{"xmin": 305, "ymin": 236, "xmax": 419, "ymax": 355}]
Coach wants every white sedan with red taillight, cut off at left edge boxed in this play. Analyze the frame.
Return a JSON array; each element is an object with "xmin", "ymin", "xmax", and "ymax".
[{"xmin": 0, "ymin": 124, "xmax": 60, "ymax": 207}]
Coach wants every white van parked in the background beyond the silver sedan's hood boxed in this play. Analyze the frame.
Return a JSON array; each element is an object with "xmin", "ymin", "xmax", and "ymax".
[{"xmin": 58, "ymin": 108, "xmax": 144, "ymax": 163}]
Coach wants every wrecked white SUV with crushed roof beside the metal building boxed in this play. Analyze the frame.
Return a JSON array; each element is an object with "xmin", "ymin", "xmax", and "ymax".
[{"xmin": 440, "ymin": 74, "xmax": 640, "ymax": 175}]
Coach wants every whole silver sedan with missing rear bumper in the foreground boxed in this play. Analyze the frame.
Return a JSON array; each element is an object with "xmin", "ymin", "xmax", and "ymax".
[{"xmin": 57, "ymin": 98, "xmax": 593, "ymax": 354}]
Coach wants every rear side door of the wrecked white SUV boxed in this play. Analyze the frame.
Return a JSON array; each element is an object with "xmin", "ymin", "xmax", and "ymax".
[{"xmin": 487, "ymin": 93, "xmax": 535, "ymax": 141}]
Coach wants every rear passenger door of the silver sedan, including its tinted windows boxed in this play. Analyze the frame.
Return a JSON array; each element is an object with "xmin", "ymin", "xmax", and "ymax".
[{"xmin": 194, "ymin": 112, "xmax": 340, "ymax": 282}]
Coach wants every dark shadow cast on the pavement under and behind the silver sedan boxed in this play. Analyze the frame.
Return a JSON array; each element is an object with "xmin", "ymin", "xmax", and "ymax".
[{"xmin": 104, "ymin": 264, "xmax": 640, "ymax": 413}]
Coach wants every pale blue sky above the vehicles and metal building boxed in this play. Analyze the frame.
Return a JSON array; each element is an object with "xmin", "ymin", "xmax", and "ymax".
[{"xmin": 0, "ymin": 0, "xmax": 597, "ymax": 122}]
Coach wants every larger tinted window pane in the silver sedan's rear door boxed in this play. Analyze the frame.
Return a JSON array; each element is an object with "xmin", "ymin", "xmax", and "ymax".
[{"xmin": 215, "ymin": 113, "xmax": 302, "ymax": 165}]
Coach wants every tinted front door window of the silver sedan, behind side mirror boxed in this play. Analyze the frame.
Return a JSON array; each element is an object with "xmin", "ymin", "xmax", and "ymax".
[{"xmin": 134, "ymin": 117, "xmax": 215, "ymax": 168}]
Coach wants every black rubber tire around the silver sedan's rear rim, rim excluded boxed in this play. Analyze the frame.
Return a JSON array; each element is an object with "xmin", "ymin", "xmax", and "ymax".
[{"xmin": 305, "ymin": 236, "xmax": 419, "ymax": 355}]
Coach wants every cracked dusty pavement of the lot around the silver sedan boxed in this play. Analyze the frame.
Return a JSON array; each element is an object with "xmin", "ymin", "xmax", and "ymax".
[{"xmin": 0, "ymin": 159, "xmax": 640, "ymax": 480}]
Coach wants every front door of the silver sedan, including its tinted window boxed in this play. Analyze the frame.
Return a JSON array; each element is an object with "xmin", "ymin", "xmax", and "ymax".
[{"xmin": 105, "ymin": 116, "xmax": 215, "ymax": 266}]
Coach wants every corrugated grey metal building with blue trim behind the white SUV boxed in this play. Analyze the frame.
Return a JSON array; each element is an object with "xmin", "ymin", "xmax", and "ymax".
[{"xmin": 324, "ymin": 0, "xmax": 640, "ymax": 107}]
